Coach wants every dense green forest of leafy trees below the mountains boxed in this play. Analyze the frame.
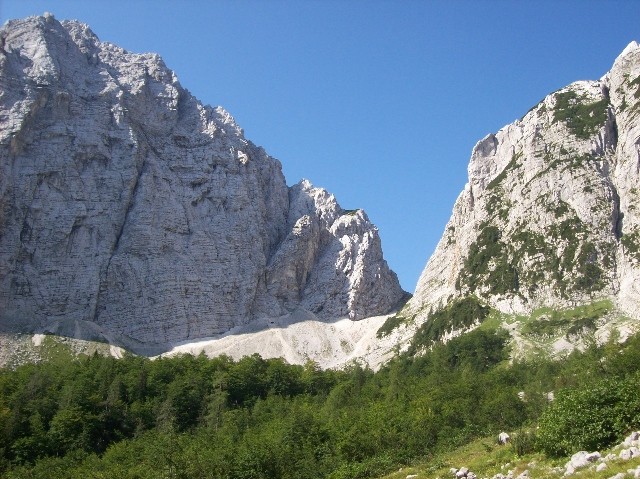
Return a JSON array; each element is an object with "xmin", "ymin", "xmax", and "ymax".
[{"xmin": 0, "ymin": 328, "xmax": 640, "ymax": 479}]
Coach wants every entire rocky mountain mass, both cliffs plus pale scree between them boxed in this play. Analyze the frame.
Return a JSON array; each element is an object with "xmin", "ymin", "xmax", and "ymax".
[{"xmin": 0, "ymin": 15, "xmax": 640, "ymax": 368}]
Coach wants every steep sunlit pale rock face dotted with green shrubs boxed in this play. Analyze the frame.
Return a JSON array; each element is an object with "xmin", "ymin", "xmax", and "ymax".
[{"xmin": 408, "ymin": 42, "xmax": 640, "ymax": 320}]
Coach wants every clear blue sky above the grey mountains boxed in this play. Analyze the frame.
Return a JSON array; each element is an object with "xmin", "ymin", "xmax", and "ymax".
[{"xmin": 0, "ymin": 0, "xmax": 640, "ymax": 291}]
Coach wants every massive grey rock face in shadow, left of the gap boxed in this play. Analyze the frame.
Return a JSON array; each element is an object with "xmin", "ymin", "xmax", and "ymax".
[{"xmin": 0, "ymin": 15, "xmax": 403, "ymax": 343}]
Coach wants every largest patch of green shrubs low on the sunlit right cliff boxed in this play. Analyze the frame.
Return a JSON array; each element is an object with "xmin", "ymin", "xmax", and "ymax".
[{"xmin": 456, "ymin": 211, "xmax": 608, "ymax": 297}]
